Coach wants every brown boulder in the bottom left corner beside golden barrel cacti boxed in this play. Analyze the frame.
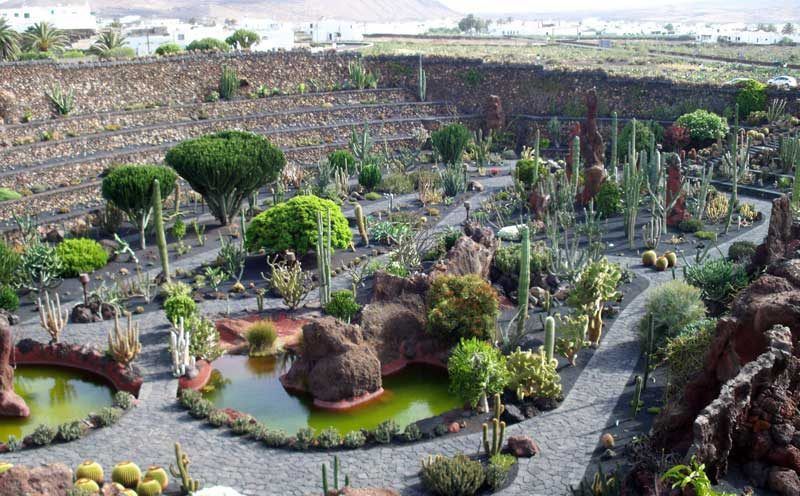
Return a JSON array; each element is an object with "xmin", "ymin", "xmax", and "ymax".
[{"xmin": 0, "ymin": 463, "xmax": 72, "ymax": 496}]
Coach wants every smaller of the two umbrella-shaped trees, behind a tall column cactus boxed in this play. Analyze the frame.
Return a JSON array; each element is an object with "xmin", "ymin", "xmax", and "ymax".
[{"xmin": 101, "ymin": 165, "xmax": 177, "ymax": 246}]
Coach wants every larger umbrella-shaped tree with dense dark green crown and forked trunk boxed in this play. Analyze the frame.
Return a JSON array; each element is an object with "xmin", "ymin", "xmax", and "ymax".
[{"xmin": 164, "ymin": 131, "xmax": 286, "ymax": 225}]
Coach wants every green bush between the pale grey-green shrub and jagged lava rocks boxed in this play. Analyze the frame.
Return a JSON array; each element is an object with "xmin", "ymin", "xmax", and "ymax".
[{"xmin": 664, "ymin": 319, "xmax": 717, "ymax": 403}]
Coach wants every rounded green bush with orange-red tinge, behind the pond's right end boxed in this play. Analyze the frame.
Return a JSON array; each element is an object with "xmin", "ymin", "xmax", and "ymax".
[{"xmin": 428, "ymin": 274, "xmax": 498, "ymax": 343}]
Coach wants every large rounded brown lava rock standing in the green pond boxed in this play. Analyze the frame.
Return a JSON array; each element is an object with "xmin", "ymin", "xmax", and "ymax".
[{"xmin": 281, "ymin": 317, "xmax": 382, "ymax": 403}]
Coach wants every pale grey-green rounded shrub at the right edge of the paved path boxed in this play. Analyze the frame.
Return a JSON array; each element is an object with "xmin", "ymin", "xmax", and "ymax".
[{"xmin": 639, "ymin": 280, "xmax": 706, "ymax": 348}]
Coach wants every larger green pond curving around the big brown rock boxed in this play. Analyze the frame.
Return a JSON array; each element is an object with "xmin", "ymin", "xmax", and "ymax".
[{"xmin": 205, "ymin": 355, "xmax": 461, "ymax": 434}]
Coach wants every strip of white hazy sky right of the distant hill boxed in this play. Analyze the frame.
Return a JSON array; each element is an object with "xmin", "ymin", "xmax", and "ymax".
[{"xmin": 440, "ymin": 0, "xmax": 692, "ymax": 13}]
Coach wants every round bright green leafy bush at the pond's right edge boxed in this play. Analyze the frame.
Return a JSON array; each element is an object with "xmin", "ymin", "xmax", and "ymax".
[{"xmin": 447, "ymin": 338, "xmax": 509, "ymax": 407}]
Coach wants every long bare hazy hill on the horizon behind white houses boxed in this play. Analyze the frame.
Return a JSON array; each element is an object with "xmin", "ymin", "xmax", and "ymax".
[{"xmin": 91, "ymin": 0, "xmax": 458, "ymax": 22}]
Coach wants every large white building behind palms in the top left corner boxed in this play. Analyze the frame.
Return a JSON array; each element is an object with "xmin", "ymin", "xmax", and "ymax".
[{"xmin": 0, "ymin": 0, "xmax": 97, "ymax": 32}]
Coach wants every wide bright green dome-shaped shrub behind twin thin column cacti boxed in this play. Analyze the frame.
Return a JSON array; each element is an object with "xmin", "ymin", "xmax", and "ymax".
[{"xmin": 245, "ymin": 195, "xmax": 353, "ymax": 257}]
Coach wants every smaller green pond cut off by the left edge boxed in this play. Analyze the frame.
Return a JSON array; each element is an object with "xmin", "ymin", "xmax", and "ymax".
[{"xmin": 0, "ymin": 365, "xmax": 114, "ymax": 442}]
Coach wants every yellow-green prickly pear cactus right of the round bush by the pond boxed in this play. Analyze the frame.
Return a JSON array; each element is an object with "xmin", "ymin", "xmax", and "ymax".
[{"xmin": 506, "ymin": 348, "xmax": 561, "ymax": 400}]
